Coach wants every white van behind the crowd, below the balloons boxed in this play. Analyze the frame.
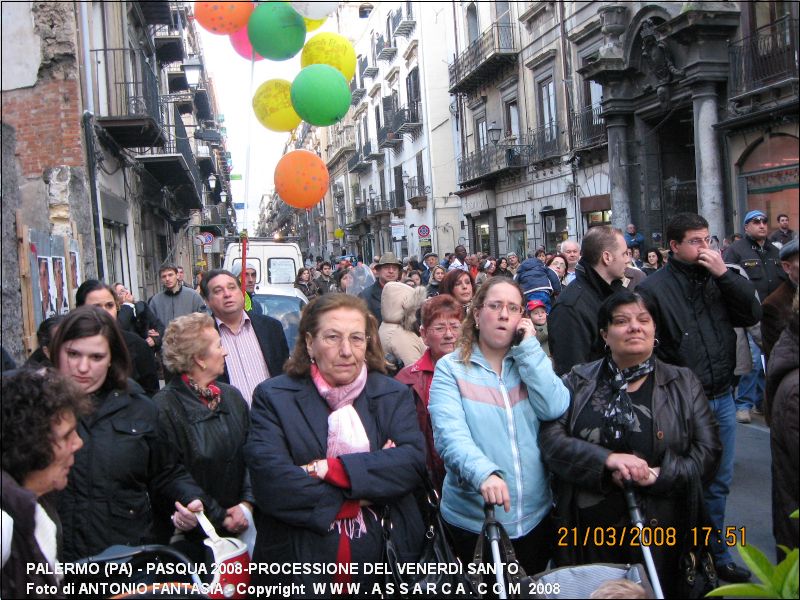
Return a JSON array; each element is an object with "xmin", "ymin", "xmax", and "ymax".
[{"xmin": 223, "ymin": 238, "xmax": 303, "ymax": 294}]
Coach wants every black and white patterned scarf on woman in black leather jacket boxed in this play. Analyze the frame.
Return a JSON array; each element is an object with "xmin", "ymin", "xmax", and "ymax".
[{"xmin": 597, "ymin": 356, "xmax": 655, "ymax": 451}]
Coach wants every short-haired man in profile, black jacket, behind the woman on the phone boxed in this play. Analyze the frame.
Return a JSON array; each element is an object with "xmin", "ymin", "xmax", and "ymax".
[{"xmin": 547, "ymin": 225, "xmax": 628, "ymax": 375}]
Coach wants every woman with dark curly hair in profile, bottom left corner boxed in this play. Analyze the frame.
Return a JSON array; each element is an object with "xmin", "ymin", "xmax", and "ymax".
[{"xmin": 0, "ymin": 367, "xmax": 91, "ymax": 598}]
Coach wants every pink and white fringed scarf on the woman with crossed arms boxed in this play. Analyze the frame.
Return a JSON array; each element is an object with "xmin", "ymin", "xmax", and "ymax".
[{"xmin": 311, "ymin": 364, "xmax": 370, "ymax": 540}]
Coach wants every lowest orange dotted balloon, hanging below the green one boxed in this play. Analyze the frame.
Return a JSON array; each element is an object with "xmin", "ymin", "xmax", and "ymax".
[{"xmin": 275, "ymin": 150, "xmax": 330, "ymax": 208}]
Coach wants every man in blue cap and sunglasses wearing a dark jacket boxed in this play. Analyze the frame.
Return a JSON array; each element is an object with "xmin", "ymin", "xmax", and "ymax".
[{"xmin": 723, "ymin": 210, "xmax": 786, "ymax": 302}]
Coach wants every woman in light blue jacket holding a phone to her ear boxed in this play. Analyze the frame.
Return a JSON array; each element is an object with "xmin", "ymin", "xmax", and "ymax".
[{"xmin": 428, "ymin": 277, "xmax": 569, "ymax": 573}]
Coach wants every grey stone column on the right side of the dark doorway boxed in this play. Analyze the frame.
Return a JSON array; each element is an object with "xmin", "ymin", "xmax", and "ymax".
[{"xmin": 692, "ymin": 81, "xmax": 726, "ymax": 239}]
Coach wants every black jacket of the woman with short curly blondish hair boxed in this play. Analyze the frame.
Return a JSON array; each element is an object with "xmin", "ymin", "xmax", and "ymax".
[{"xmin": 153, "ymin": 377, "xmax": 253, "ymax": 541}]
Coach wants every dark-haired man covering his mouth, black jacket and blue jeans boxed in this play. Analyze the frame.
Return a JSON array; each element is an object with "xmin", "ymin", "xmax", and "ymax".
[{"xmin": 636, "ymin": 213, "xmax": 761, "ymax": 582}]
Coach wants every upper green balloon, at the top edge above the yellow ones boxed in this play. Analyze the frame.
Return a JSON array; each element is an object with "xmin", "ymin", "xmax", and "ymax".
[{"xmin": 247, "ymin": 2, "xmax": 306, "ymax": 60}]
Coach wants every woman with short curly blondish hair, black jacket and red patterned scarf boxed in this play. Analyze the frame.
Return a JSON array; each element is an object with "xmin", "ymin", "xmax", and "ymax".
[{"xmin": 153, "ymin": 313, "xmax": 253, "ymax": 553}]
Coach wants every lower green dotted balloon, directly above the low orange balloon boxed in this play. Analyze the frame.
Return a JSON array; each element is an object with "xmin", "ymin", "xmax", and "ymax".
[{"xmin": 291, "ymin": 64, "xmax": 351, "ymax": 127}]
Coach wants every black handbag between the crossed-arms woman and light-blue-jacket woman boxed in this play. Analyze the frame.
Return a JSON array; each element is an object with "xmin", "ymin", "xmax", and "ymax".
[{"xmin": 381, "ymin": 475, "xmax": 480, "ymax": 598}]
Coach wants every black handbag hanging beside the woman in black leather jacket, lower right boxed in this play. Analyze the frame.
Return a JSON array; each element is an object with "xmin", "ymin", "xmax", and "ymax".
[{"xmin": 676, "ymin": 464, "xmax": 719, "ymax": 598}]
